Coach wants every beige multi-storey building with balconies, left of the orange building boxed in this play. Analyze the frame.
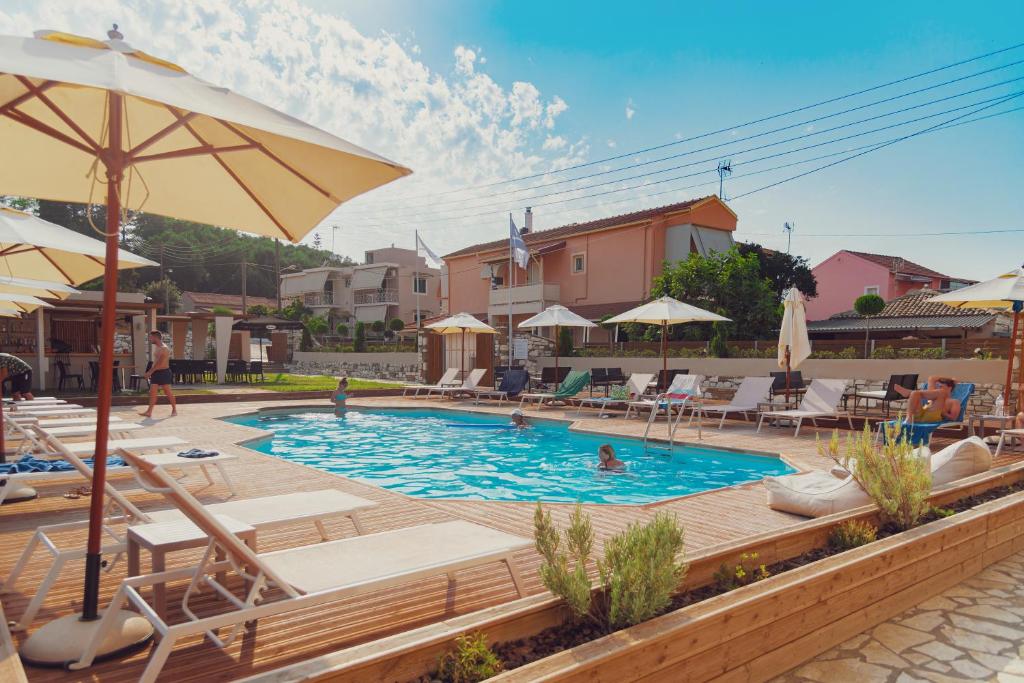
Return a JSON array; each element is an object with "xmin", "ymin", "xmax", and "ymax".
[{"xmin": 281, "ymin": 247, "xmax": 441, "ymax": 329}]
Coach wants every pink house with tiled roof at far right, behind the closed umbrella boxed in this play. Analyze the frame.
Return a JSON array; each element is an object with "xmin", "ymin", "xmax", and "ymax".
[{"xmin": 807, "ymin": 249, "xmax": 974, "ymax": 321}]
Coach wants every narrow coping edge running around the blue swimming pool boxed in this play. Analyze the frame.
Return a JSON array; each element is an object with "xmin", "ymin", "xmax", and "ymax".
[{"xmin": 217, "ymin": 403, "xmax": 809, "ymax": 509}]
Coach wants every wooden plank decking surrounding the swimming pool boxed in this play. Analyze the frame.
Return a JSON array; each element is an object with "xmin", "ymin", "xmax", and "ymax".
[{"xmin": 0, "ymin": 398, "xmax": 1016, "ymax": 683}]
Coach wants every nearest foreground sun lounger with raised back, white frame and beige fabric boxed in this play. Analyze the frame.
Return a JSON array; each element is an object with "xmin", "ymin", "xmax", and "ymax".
[{"xmin": 69, "ymin": 453, "xmax": 534, "ymax": 683}]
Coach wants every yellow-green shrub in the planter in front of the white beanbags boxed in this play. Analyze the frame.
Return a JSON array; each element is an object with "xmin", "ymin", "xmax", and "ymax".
[{"xmin": 818, "ymin": 419, "xmax": 932, "ymax": 529}]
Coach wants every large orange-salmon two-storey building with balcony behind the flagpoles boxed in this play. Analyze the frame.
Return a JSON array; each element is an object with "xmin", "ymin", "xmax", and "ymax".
[{"xmin": 441, "ymin": 196, "xmax": 736, "ymax": 341}]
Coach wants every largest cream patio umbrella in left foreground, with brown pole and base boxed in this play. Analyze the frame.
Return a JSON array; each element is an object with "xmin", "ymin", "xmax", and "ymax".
[{"xmin": 0, "ymin": 27, "xmax": 410, "ymax": 663}]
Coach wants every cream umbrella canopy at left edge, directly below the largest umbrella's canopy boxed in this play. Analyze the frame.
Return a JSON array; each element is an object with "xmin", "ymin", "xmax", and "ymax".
[{"xmin": 0, "ymin": 208, "xmax": 160, "ymax": 285}]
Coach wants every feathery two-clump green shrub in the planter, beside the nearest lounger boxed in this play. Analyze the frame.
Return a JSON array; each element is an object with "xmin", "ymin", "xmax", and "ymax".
[{"xmin": 534, "ymin": 503, "xmax": 686, "ymax": 632}]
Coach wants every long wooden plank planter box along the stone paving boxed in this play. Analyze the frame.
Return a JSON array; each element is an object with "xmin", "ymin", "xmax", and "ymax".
[{"xmin": 249, "ymin": 463, "xmax": 1024, "ymax": 683}]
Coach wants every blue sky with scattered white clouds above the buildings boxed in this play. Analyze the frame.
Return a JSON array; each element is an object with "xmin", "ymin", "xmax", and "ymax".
[{"xmin": 0, "ymin": 0, "xmax": 1024, "ymax": 279}]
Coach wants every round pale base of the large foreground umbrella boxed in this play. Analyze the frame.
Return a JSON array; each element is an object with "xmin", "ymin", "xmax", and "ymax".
[{"xmin": 20, "ymin": 609, "xmax": 153, "ymax": 667}]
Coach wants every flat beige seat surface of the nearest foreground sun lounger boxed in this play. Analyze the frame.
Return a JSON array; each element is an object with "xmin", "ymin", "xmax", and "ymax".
[{"xmin": 259, "ymin": 520, "xmax": 532, "ymax": 595}]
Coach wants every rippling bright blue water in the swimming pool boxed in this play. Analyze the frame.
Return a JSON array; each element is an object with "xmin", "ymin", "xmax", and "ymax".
[{"xmin": 228, "ymin": 410, "xmax": 795, "ymax": 504}]
